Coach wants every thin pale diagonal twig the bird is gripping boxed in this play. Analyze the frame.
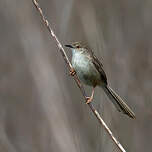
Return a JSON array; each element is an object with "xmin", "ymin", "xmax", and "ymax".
[{"xmin": 32, "ymin": 0, "xmax": 126, "ymax": 152}]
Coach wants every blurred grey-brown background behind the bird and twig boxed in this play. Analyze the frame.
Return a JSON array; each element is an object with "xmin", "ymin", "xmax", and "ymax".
[{"xmin": 0, "ymin": 0, "xmax": 152, "ymax": 152}]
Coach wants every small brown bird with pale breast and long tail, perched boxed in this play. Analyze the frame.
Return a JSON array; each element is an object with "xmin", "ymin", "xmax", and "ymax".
[{"xmin": 65, "ymin": 42, "xmax": 135, "ymax": 118}]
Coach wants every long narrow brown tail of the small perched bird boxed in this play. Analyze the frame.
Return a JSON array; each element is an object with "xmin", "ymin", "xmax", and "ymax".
[{"xmin": 102, "ymin": 86, "xmax": 135, "ymax": 119}]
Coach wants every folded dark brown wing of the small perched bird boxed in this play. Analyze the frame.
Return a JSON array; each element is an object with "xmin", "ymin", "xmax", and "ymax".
[{"xmin": 87, "ymin": 48, "xmax": 107, "ymax": 84}]
